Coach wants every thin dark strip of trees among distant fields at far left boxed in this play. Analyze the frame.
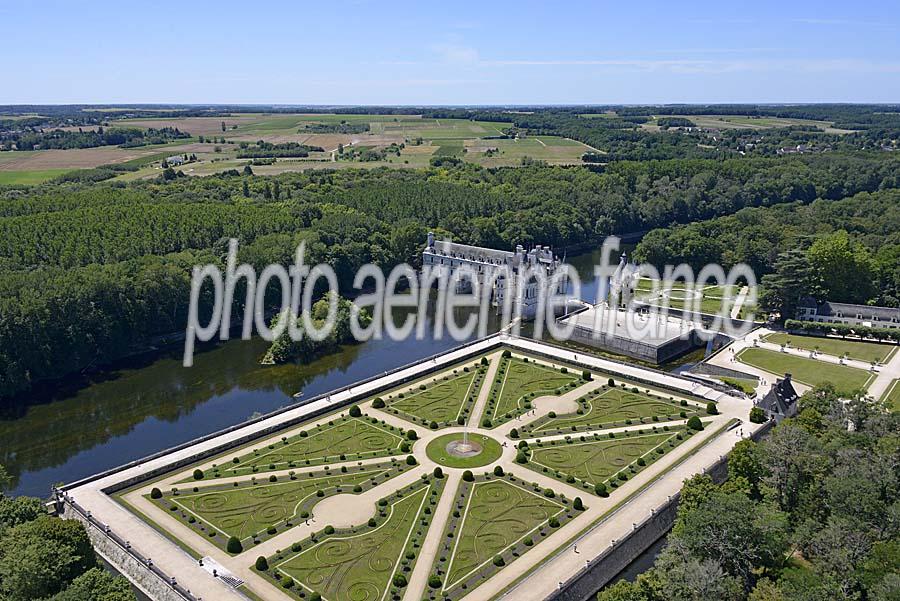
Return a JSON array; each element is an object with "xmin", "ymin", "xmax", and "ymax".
[{"xmin": 0, "ymin": 127, "xmax": 191, "ymax": 151}]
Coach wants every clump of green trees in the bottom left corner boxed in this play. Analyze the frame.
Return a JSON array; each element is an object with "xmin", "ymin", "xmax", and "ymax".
[{"xmin": 0, "ymin": 465, "xmax": 135, "ymax": 601}]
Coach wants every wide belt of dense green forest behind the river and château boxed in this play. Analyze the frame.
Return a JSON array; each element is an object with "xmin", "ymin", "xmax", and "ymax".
[{"xmin": 0, "ymin": 153, "xmax": 900, "ymax": 399}]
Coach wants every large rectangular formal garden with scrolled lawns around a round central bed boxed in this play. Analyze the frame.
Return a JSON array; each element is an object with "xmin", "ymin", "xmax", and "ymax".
[{"xmin": 128, "ymin": 351, "xmax": 728, "ymax": 601}]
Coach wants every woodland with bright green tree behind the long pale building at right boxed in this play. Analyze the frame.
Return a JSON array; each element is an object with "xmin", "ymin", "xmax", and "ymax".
[{"xmin": 635, "ymin": 190, "xmax": 900, "ymax": 318}]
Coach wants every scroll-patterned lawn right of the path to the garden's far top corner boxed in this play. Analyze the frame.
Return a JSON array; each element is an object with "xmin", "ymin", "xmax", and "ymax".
[{"xmin": 485, "ymin": 357, "xmax": 582, "ymax": 426}]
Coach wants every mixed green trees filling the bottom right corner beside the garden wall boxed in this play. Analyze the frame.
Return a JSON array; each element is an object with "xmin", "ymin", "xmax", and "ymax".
[{"xmin": 598, "ymin": 385, "xmax": 900, "ymax": 601}]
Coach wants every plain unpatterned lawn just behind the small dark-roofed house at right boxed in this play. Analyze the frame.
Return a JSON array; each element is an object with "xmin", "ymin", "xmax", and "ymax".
[{"xmin": 737, "ymin": 348, "xmax": 871, "ymax": 394}]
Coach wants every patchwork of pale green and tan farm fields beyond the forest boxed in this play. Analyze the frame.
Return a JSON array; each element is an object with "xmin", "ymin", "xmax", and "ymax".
[{"xmin": 0, "ymin": 113, "xmax": 591, "ymax": 184}]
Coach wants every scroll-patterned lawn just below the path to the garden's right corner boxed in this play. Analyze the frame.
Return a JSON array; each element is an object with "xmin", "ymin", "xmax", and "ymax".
[{"xmin": 526, "ymin": 431, "xmax": 678, "ymax": 486}]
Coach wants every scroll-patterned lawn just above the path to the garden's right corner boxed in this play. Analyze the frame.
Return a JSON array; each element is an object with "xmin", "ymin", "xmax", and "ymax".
[{"xmin": 521, "ymin": 386, "xmax": 699, "ymax": 436}]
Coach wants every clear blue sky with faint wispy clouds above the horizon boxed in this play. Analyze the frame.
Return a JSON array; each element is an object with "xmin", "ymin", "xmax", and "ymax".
[{"xmin": 0, "ymin": 0, "xmax": 900, "ymax": 105}]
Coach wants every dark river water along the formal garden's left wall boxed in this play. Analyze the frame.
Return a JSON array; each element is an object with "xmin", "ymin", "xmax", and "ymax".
[{"xmin": 0, "ymin": 245, "xmax": 684, "ymax": 497}]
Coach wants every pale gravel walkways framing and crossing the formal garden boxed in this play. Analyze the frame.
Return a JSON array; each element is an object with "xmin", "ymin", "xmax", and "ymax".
[{"xmin": 61, "ymin": 335, "xmax": 759, "ymax": 600}]
